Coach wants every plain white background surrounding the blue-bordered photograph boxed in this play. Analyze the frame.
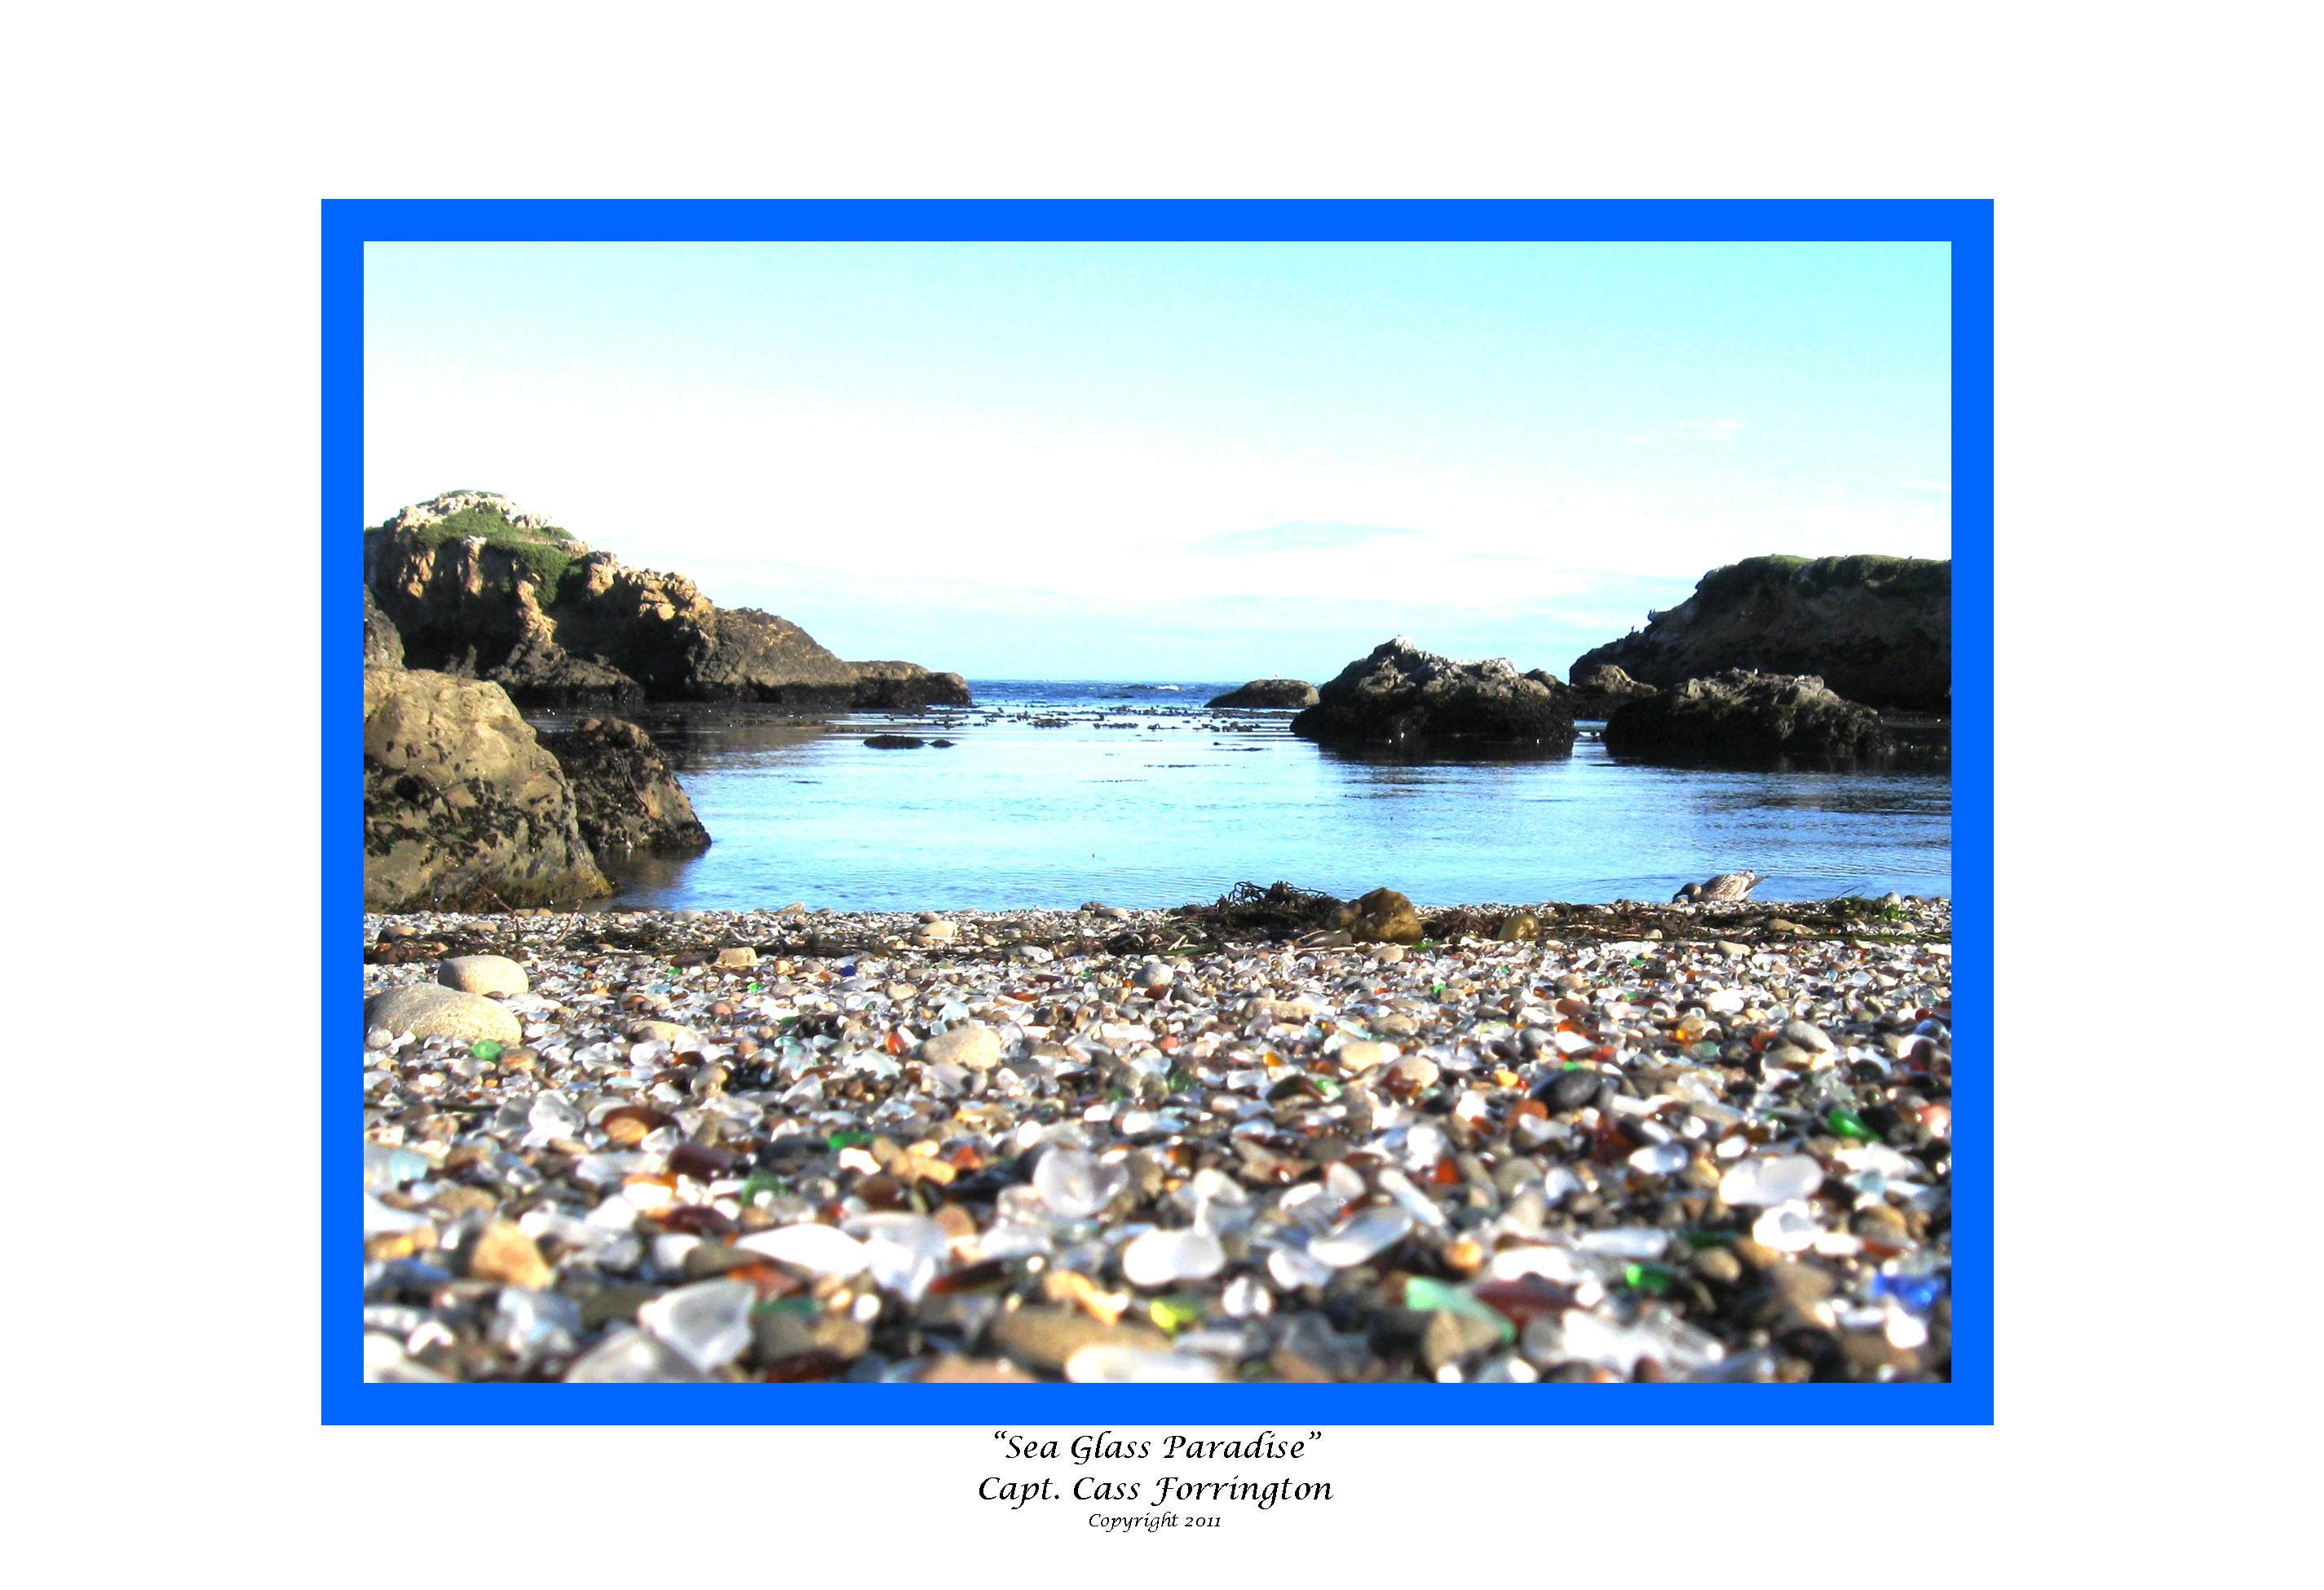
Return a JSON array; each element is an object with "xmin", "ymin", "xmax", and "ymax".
[{"xmin": 0, "ymin": 2, "xmax": 2317, "ymax": 1585}]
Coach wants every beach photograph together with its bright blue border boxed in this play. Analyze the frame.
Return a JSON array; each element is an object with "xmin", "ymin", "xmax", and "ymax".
[{"xmin": 320, "ymin": 200, "xmax": 1994, "ymax": 1427}]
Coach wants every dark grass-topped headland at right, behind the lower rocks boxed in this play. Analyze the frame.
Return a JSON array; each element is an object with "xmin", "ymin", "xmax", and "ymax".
[{"xmin": 1571, "ymin": 554, "xmax": 1952, "ymax": 711}]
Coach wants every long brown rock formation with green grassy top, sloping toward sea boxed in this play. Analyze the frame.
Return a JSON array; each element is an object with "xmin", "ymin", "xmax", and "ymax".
[{"xmin": 363, "ymin": 492, "xmax": 969, "ymax": 711}]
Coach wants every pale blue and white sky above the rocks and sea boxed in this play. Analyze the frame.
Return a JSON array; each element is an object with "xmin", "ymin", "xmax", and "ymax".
[{"xmin": 365, "ymin": 241, "xmax": 1952, "ymax": 681}]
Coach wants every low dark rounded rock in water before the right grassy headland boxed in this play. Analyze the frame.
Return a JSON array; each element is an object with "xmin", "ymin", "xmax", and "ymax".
[{"xmin": 1606, "ymin": 669, "xmax": 1897, "ymax": 770}]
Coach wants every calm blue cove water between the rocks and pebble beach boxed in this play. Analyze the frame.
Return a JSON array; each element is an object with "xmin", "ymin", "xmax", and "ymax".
[{"xmin": 541, "ymin": 681, "xmax": 1952, "ymax": 912}]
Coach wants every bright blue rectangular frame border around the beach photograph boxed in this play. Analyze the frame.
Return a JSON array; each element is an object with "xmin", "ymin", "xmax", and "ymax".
[{"xmin": 332, "ymin": 200, "xmax": 1994, "ymax": 1425}]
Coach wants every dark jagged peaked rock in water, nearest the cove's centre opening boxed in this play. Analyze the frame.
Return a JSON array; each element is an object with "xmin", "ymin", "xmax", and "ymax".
[{"xmin": 1292, "ymin": 634, "xmax": 1573, "ymax": 756}]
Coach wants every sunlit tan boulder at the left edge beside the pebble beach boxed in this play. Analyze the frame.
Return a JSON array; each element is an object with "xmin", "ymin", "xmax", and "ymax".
[{"xmin": 363, "ymin": 667, "xmax": 613, "ymax": 912}]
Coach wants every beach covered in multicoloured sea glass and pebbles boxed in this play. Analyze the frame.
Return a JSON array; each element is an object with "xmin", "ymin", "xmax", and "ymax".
[{"xmin": 365, "ymin": 899, "xmax": 1952, "ymax": 1380}]
